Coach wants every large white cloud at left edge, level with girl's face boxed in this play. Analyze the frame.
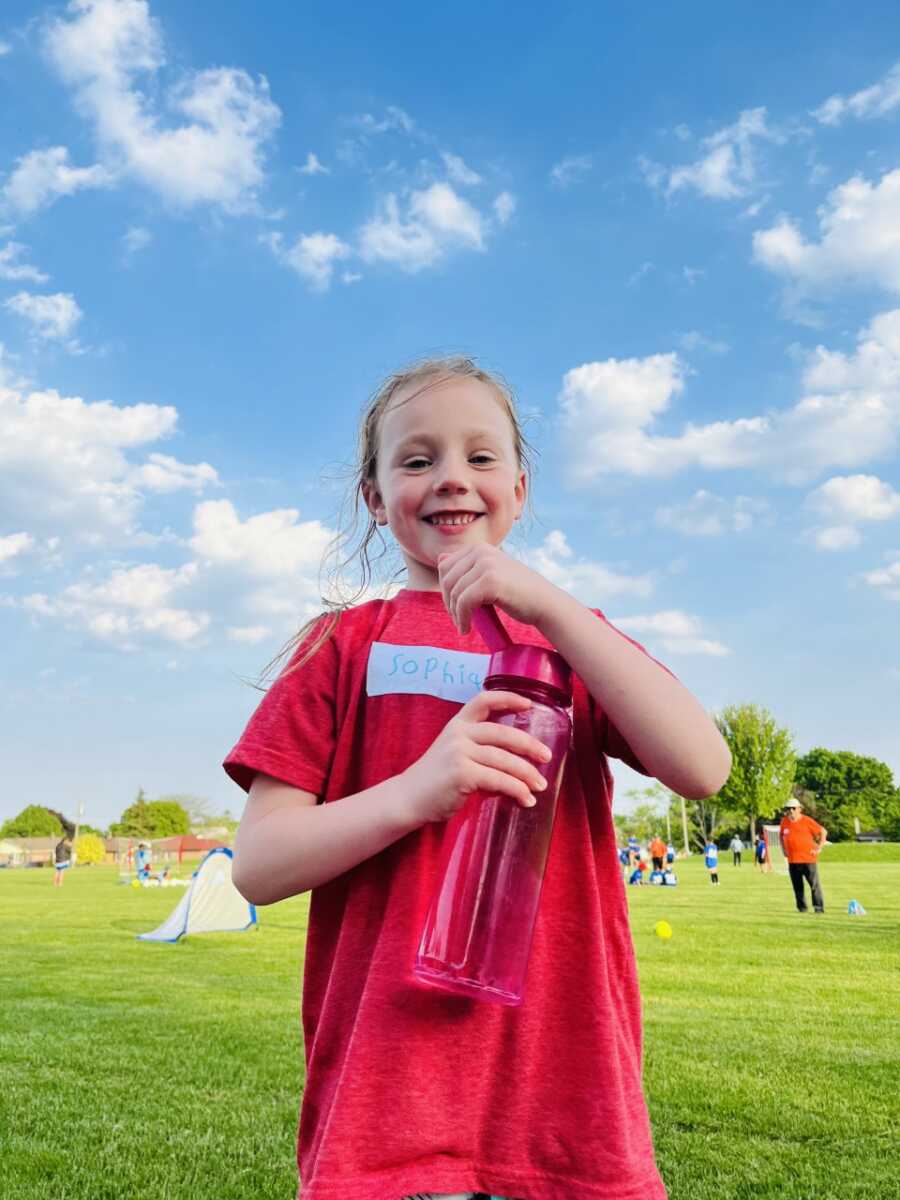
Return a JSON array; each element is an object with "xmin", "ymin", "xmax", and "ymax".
[{"xmin": 0, "ymin": 376, "xmax": 215, "ymax": 544}]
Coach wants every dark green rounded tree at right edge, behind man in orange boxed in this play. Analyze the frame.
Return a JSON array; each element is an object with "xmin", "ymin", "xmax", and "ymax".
[{"xmin": 797, "ymin": 746, "xmax": 900, "ymax": 841}]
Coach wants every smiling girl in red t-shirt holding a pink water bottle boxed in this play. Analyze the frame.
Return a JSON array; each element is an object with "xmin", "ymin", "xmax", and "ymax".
[{"xmin": 226, "ymin": 359, "xmax": 730, "ymax": 1200}]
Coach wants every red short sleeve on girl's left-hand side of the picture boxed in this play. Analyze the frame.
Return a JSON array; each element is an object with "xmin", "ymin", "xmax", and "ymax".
[{"xmin": 223, "ymin": 625, "xmax": 340, "ymax": 796}]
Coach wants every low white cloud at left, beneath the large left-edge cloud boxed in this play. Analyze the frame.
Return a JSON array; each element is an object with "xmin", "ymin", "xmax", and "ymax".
[{"xmin": 22, "ymin": 563, "xmax": 211, "ymax": 650}]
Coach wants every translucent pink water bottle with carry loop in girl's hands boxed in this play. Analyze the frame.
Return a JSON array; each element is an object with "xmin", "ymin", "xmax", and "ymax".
[{"xmin": 413, "ymin": 606, "xmax": 572, "ymax": 1004}]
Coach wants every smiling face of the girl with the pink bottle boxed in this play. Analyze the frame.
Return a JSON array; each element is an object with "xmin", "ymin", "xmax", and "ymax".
[{"xmin": 364, "ymin": 376, "xmax": 526, "ymax": 590}]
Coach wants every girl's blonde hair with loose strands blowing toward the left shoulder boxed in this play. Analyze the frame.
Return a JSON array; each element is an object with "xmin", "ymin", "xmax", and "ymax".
[{"xmin": 259, "ymin": 355, "xmax": 534, "ymax": 685}]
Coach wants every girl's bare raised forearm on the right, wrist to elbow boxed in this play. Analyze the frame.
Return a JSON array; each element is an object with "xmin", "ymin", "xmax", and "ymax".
[{"xmin": 535, "ymin": 588, "xmax": 731, "ymax": 799}]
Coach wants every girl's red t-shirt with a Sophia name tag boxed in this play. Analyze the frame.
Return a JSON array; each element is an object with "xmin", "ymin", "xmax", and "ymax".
[{"xmin": 226, "ymin": 592, "xmax": 666, "ymax": 1200}]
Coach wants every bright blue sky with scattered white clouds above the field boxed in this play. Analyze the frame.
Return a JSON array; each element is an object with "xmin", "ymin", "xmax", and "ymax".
[{"xmin": 0, "ymin": 0, "xmax": 900, "ymax": 824}]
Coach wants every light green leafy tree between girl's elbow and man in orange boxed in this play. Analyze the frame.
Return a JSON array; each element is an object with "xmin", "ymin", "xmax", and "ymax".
[{"xmin": 706, "ymin": 704, "xmax": 797, "ymax": 839}]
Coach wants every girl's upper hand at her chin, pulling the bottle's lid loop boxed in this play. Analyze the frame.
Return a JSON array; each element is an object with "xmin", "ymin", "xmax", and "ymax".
[{"xmin": 438, "ymin": 545, "xmax": 557, "ymax": 634}]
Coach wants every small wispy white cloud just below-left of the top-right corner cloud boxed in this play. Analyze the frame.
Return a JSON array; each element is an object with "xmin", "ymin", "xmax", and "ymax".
[{"xmin": 652, "ymin": 107, "xmax": 786, "ymax": 199}]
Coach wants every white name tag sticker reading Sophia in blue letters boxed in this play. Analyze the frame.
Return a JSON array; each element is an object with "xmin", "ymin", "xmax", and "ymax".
[{"xmin": 366, "ymin": 642, "xmax": 491, "ymax": 704}]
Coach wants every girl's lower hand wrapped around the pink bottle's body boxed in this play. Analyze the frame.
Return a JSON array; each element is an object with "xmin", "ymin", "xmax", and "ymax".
[{"xmin": 401, "ymin": 691, "xmax": 552, "ymax": 823}]
